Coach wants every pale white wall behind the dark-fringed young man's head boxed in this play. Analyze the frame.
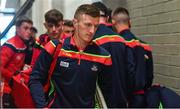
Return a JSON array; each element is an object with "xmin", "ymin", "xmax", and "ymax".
[{"xmin": 32, "ymin": 0, "xmax": 101, "ymax": 35}]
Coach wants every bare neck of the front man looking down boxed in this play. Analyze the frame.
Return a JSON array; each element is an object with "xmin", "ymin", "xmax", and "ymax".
[{"xmin": 73, "ymin": 34, "xmax": 88, "ymax": 50}]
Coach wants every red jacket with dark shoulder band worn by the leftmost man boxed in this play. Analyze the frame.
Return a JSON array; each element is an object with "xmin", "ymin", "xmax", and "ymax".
[{"xmin": 0, "ymin": 35, "xmax": 26, "ymax": 93}]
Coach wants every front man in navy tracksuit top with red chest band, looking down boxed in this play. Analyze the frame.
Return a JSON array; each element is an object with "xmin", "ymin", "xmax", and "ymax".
[{"xmin": 29, "ymin": 4, "xmax": 112, "ymax": 108}]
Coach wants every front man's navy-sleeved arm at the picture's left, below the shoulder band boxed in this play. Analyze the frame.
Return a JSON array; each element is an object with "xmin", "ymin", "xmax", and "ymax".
[{"xmin": 29, "ymin": 50, "xmax": 52, "ymax": 107}]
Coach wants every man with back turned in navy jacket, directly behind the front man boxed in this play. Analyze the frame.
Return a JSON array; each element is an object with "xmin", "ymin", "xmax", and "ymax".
[{"xmin": 93, "ymin": 2, "xmax": 135, "ymax": 108}]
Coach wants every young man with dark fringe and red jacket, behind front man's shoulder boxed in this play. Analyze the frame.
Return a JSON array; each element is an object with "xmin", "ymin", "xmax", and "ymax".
[{"xmin": 22, "ymin": 9, "xmax": 63, "ymax": 83}]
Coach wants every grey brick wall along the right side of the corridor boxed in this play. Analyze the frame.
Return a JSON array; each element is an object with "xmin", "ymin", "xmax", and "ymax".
[{"xmin": 105, "ymin": 0, "xmax": 180, "ymax": 94}]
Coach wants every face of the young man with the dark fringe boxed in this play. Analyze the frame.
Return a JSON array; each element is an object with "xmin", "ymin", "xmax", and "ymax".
[{"xmin": 44, "ymin": 21, "xmax": 63, "ymax": 39}]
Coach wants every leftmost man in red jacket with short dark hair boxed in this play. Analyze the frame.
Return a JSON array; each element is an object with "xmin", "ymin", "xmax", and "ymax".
[{"xmin": 0, "ymin": 17, "xmax": 33, "ymax": 108}]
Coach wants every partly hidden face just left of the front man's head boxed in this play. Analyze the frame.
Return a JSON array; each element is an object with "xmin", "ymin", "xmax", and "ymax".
[{"xmin": 63, "ymin": 25, "xmax": 74, "ymax": 36}]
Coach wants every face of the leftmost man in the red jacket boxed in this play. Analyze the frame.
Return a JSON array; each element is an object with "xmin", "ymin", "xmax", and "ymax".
[{"xmin": 16, "ymin": 22, "xmax": 32, "ymax": 40}]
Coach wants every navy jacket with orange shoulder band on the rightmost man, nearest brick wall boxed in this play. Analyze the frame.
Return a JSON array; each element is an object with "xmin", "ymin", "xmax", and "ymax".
[{"xmin": 119, "ymin": 29, "xmax": 153, "ymax": 92}]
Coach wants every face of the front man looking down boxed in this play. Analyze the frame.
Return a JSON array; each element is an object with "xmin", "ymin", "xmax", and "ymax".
[{"xmin": 74, "ymin": 14, "xmax": 99, "ymax": 43}]
